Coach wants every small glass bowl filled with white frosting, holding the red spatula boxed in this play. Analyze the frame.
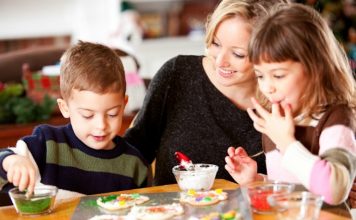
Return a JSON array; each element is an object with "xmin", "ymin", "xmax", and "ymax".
[{"xmin": 172, "ymin": 163, "xmax": 219, "ymax": 191}]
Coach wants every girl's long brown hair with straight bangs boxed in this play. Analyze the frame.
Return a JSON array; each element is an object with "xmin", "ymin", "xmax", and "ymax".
[{"xmin": 249, "ymin": 3, "xmax": 356, "ymax": 116}]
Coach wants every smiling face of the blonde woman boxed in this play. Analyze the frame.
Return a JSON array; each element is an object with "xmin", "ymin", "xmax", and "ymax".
[{"xmin": 208, "ymin": 17, "xmax": 254, "ymax": 86}]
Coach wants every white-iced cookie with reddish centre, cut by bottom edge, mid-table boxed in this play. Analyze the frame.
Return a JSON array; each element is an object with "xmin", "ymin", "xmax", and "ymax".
[{"xmin": 129, "ymin": 203, "xmax": 184, "ymax": 220}]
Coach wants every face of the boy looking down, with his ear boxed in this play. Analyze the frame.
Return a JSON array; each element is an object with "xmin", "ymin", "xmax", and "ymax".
[{"xmin": 58, "ymin": 89, "xmax": 128, "ymax": 150}]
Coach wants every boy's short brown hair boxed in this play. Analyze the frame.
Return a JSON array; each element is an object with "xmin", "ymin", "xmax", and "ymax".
[{"xmin": 60, "ymin": 41, "xmax": 126, "ymax": 100}]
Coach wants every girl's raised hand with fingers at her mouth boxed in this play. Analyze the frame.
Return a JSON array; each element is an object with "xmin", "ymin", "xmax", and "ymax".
[{"xmin": 247, "ymin": 98, "xmax": 296, "ymax": 153}]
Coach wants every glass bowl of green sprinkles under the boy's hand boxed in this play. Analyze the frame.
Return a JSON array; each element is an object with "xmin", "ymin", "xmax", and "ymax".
[{"xmin": 9, "ymin": 185, "xmax": 58, "ymax": 215}]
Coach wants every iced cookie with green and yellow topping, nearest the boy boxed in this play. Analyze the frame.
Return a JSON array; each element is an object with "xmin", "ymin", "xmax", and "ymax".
[{"xmin": 96, "ymin": 193, "xmax": 149, "ymax": 211}]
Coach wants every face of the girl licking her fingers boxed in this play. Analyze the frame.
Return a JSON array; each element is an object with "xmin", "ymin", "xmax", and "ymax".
[{"xmin": 254, "ymin": 61, "xmax": 308, "ymax": 113}]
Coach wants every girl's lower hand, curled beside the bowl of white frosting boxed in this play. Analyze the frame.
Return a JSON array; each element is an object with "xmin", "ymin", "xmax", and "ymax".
[{"xmin": 225, "ymin": 147, "xmax": 257, "ymax": 185}]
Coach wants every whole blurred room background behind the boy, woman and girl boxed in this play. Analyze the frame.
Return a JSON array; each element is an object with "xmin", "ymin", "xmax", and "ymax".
[{"xmin": 0, "ymin": 0, "xmax": 356, "ymax": 144}]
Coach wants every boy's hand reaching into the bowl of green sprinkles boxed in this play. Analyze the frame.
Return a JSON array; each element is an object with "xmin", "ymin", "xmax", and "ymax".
[{"xmin": 3, "ymin": 155, "xmax": 36, "ymax": 194}]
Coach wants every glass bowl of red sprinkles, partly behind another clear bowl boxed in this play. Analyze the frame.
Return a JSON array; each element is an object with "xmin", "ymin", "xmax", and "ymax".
[{"xmin": 247, "ymin": 182, "xmax": 295, "ymax": 214}]
